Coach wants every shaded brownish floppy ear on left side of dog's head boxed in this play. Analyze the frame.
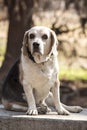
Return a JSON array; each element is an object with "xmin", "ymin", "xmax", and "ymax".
[{"xmin": 22, "ymin": 31, "xmax": 28, "ymax": 55}]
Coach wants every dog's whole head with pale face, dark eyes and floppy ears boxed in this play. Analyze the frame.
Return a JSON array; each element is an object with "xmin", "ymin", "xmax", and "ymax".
[{"xmin": 23, "ymin": 26, "xmax": 58, "ymax": 63}]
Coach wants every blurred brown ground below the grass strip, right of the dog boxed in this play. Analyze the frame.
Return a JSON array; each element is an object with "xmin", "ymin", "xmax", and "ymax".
[{"xmin": 60, "ymin": 80, "xmax": 87, "ymax": 107}]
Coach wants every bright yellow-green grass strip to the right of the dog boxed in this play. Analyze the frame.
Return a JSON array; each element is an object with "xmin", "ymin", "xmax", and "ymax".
[{"xmin": 59, "ymin": 67, "xmax": 87, "ymax": 80}]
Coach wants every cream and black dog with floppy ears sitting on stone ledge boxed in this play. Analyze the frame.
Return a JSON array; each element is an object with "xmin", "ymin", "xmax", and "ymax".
[{"xmin": 2, "ymin": 26, "xmax": 82, "ymax": 115}]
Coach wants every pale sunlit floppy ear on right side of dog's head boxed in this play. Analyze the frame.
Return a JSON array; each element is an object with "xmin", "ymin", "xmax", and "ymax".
[{"xmin": 50, "ymin": 30, "xmax": 58, "ymax": 55}]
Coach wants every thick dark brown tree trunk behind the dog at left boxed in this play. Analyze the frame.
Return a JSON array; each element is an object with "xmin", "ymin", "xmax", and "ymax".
[{"xmin": 0, "ymin": 0, "xmax": 34, "ymax": 93}]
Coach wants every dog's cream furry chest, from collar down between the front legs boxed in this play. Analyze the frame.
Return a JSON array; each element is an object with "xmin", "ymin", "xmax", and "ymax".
[{"xmin": 22, "ymin": 55, "xmax": 57, "ymax": 100}]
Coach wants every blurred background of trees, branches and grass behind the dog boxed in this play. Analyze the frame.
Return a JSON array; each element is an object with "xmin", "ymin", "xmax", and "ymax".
[{"xmin": 0, "ymin": 0, "xmax": 87, "ymax": 107}]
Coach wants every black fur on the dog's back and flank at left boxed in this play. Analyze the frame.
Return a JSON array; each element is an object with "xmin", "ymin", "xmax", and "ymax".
[{"xmin": 2, "ymin": 60, "xmax": 26, "ymax": 103}]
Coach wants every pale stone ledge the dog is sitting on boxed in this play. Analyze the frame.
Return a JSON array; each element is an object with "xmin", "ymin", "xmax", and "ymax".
[{"xmin": 0, "ymin": 105, "xmax": 87, "ymax": 130}]
